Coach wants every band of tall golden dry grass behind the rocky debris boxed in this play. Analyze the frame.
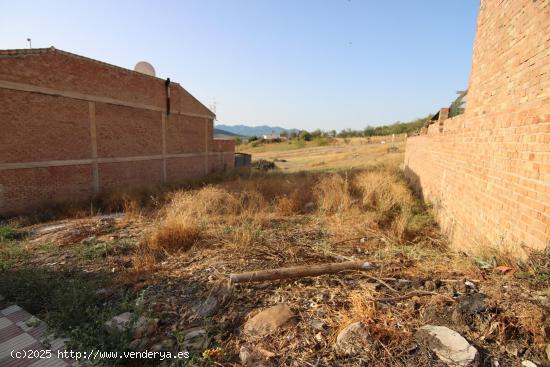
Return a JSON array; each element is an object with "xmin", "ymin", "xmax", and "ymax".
[{"xmin": 130, "ymin": 165, "xmax": 432, "ymax": 270}]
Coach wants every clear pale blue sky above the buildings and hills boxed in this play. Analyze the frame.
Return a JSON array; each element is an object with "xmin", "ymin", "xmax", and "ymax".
[{"xmin": 0, "ymin": 0, "xmax": 479, "ymax": 130}]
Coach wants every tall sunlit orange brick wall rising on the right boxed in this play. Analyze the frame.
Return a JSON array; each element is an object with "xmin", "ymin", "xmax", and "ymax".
[{"xmin": 404, "ymin": 0, "xmax": 550, "ymax": 256}]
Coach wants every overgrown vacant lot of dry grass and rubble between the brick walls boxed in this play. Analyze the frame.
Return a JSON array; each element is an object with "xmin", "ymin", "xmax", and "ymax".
[{"xmin": 0, "ymin": 140, "xmax": 550, "ymax": 366}]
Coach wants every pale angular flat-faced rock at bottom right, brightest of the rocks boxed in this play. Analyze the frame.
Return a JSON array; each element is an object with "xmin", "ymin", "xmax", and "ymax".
[{"xmin": 416, "ymin": 325, "xmax": 479, "ymax": 367}]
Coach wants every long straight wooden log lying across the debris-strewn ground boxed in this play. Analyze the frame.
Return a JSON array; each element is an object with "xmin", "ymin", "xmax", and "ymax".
[{"xmin": 229, "ymin": 261, "xmax": 374, "ymax": 284}]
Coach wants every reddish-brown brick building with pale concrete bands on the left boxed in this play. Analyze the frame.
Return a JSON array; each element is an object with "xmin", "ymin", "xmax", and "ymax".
[{"xmin": 0, "ymin": 47, "xmax": 234, "ymax": 215}]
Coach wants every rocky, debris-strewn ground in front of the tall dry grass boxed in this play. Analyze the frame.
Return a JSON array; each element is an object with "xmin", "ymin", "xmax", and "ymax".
[{"xmin": 3, "ymin": 216, "xmax": 550, "ymax": 366}]
